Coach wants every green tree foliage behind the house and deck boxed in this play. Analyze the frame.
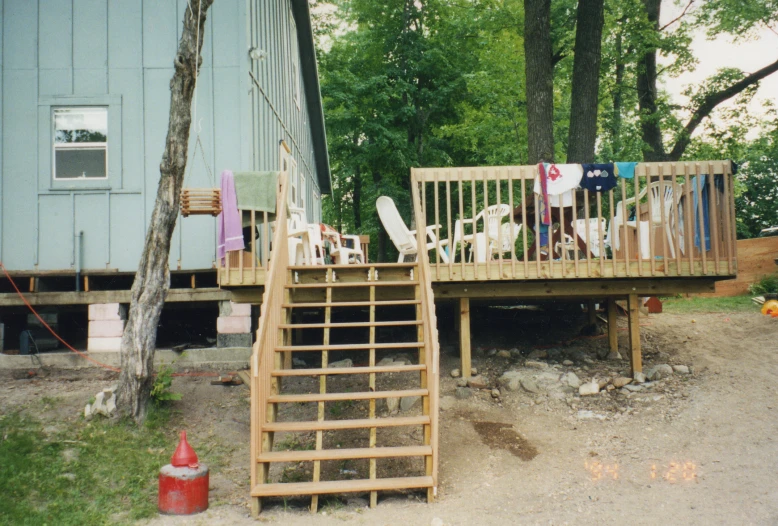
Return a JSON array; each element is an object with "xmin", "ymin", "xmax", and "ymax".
[{"xmin": 314, "ymin": 0, "xmax": 778, "ymax": 248}]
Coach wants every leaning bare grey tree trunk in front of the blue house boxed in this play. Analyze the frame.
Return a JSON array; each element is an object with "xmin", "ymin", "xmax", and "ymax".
[{"xmin": 118, "ymin": 0, "xmax": 213, "ymax": 423}]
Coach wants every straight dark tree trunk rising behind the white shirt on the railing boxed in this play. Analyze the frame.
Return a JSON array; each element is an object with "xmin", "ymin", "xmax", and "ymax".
[{"xmin": 524, "ymin": 0, "xmax": 554, "ymax": 164}]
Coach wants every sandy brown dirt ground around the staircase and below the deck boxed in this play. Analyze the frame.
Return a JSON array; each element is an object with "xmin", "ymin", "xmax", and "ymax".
[{"xmin": 0, "ymin": 309, "xmax": 778, "ymax": 526}]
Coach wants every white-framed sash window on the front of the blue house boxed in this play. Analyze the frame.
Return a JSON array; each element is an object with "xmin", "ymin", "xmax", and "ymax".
[{"xmin": 52, "ymin": 106, "xmax": 108, "ymax": 181}]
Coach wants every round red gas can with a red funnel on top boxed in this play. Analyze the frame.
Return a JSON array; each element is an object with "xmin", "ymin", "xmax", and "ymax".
[{"xmin": 158, "ymin": 431, "xmax": 209, "ymax": 515}]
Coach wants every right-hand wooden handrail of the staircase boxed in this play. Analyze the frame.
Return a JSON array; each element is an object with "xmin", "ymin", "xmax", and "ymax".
[{"xmin": 411, "ymin": 169, "xmax": 440, "ymax": 496}]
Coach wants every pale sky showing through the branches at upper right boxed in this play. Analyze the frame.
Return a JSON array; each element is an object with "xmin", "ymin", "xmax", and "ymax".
[{"xmin": 660, "ymin": 0, "xmax": 778, "ymax": 125}]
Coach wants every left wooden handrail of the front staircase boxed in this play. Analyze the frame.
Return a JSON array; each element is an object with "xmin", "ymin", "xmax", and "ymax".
[{"xmin": 250, "ymin": 159, "xmax": 289, "ymax": 498}]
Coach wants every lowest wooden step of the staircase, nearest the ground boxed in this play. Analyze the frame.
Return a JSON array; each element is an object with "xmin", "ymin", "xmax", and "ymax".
[{"xmin": 251, "ymin": 477, "xmax": 434, "ymax": 497}]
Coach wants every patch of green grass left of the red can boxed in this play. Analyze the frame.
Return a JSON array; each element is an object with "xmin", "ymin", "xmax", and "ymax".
[{"xmin": 0, "ymin": 409, "xmax": 175, "ymax": 526}]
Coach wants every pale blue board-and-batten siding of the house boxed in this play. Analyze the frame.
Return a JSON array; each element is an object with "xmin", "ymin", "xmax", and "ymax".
[{"xmin": 0, "ymin": 0, "xmax": 328, "ymax": 271}]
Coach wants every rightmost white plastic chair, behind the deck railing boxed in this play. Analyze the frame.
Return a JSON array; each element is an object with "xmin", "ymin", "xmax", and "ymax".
[{"xmin": 608, "ymin": 181, "xmax": 682, "ymax": 259}]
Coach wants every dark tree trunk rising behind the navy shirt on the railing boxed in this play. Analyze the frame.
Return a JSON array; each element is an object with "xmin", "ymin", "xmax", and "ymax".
[{"xmin": 567, "ymin": 0, "xmax": 604, "ymax": 163}]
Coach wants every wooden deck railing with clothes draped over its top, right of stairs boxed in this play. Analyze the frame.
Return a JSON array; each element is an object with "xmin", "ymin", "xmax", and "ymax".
[{"xmin": 411, "ymin": 161, "xmax": 737, "ymax": 281}]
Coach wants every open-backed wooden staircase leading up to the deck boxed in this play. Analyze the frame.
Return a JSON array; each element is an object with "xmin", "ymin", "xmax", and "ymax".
[{"xmin": 251, "ymin": 264, "xmax": 439, "ymax": 514}]
